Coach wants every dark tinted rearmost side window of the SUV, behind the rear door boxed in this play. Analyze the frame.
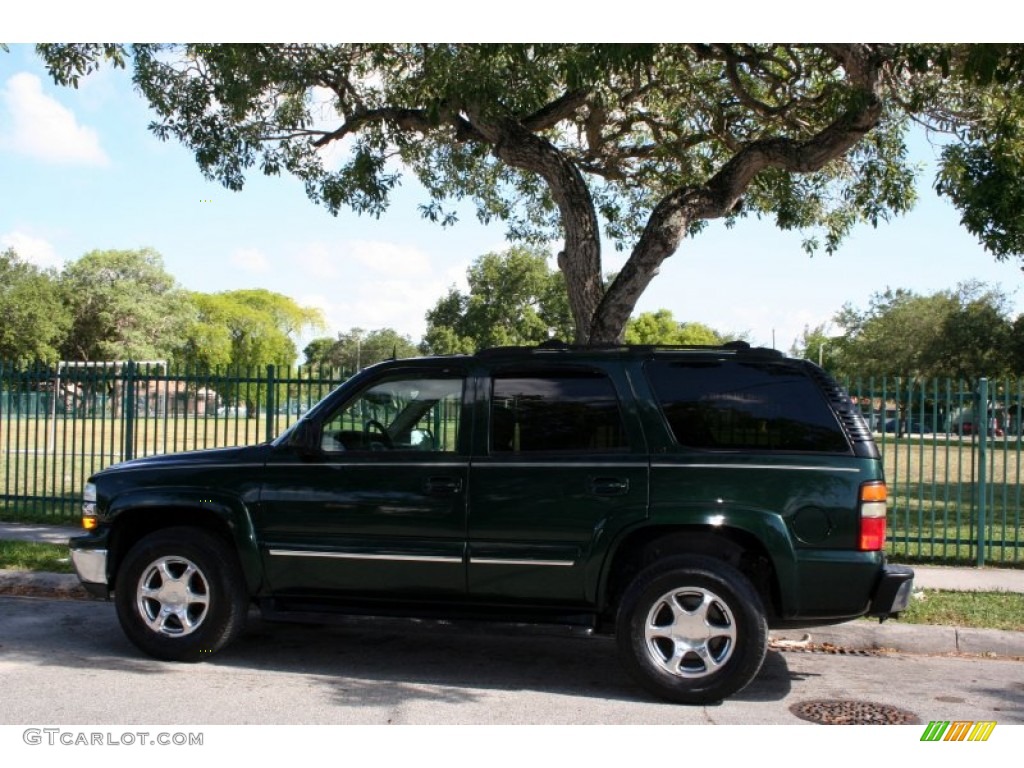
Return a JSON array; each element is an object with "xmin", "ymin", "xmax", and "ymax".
[{"xmin": 647, "ymin": 359, "xmax": 850, "ymax": 454}]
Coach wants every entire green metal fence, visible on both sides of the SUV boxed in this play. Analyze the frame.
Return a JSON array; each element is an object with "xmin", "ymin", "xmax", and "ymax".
[{"xmin": 0, "ymin": 364, "xmax": 1024, "ymax": 566}]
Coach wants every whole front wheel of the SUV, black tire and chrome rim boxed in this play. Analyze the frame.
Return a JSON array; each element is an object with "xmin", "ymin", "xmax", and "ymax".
[{"xmin": 114, "ymin": 527, "xmax": 248, "ymax": 662}]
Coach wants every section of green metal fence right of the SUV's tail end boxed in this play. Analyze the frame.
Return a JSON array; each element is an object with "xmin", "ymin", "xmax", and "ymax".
[{"xmin": 849, "ymin": 378, "xmax": 1024, "ymax": 565}]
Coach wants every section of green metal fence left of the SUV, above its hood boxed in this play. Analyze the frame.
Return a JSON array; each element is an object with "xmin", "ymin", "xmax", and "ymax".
[{"xmin": 0, "ymin": 362, "xmax": 346, "ymax": 522}]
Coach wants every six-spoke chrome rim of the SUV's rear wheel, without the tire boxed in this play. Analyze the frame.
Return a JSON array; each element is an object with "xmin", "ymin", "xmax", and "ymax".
[{"xmin": 644, "ymin": 587, "xmax": 736, "ymax": 678}]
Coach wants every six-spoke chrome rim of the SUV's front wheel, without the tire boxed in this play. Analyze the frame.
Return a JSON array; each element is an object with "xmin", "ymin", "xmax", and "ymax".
[{"xmin": 136, "ymin": 556, "xmax": 210, "ymax": 637}]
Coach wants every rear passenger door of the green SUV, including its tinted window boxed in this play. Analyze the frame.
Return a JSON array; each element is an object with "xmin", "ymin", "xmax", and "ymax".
[{"xmin": 468, "ymin": 364, "xmax": 648, "ymax": 606}]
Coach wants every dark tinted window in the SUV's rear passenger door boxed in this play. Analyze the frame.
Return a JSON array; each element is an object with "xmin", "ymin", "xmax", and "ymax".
[{"xmin": 489, "ymin": 371, "xmax": 629, "ymax": 455}]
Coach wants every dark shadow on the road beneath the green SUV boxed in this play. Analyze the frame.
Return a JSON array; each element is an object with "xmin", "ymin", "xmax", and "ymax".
[{"xmin": 218, "ymin": 614, "xmax": 792, "ymax": 706}]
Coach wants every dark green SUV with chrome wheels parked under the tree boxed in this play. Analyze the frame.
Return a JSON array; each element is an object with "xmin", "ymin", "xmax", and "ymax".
[{"xmin": 71, "ymin": 343, "xmax": 913, "ymax": 703}]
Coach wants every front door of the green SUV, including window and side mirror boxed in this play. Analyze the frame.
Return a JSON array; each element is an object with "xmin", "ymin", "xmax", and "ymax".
[{"xmin": 260, "ymin": 369, "xmax": 469, "ymax": 601}]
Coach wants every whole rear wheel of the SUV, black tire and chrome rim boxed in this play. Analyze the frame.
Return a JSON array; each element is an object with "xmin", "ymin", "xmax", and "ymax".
[{"xmin": 615, "ymin": 555, "xmax": 768, "ymax": 703}]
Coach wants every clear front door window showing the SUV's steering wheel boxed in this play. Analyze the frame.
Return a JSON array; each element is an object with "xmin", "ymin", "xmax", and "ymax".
[{"xmin": 321, "ymin": 376, "xmax": 464, "ymax": 454}]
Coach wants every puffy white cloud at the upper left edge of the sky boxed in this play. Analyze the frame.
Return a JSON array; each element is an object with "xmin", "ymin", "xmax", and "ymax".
[{"xmin": 0, "ymin": 72, "xmax": 110, "ymax": 166}]
